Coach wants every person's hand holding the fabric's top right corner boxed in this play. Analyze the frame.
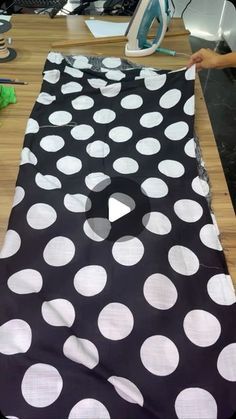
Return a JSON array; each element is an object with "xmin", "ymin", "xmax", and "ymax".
[{"xmin": 187, "ymin": 48, "xmax": 222, "ymax": 71}]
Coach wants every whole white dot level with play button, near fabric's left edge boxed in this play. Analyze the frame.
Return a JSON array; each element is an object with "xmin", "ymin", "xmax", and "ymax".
[{"xmin": 26, "ymin": 203, "xmax": 57, "ymax": 230}]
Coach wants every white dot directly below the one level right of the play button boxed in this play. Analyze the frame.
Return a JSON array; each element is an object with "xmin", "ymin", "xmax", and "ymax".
[{"xmin": 168, "ymin": 246, "xmax": 199, "ymax": 276}]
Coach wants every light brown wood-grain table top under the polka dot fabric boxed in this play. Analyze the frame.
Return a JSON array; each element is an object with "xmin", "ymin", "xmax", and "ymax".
[{"xmin": 0, "ymin": 15, "xmax": 236, "ymax": 284}]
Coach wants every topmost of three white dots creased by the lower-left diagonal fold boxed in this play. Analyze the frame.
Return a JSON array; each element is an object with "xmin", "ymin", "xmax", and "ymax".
[{"xmin": 42, "ymin": 298, "xmax": 75, "ymax": 327}]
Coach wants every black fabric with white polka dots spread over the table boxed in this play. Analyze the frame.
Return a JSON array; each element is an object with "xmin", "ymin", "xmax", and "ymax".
[{"xmin": 0, "ymin": 52, "xmax": 236, "ymax": 419}]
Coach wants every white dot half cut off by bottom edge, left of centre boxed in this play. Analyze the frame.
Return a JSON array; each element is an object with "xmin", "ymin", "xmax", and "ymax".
[{"xmin": 68, "ymin": 399, "xmax": 110, "ymax": 419}]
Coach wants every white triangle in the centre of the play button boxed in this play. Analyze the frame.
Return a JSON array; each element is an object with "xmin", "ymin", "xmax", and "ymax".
[{"xmin": 108, "ymin": 192, "xmax": 135, "ymax": 223}]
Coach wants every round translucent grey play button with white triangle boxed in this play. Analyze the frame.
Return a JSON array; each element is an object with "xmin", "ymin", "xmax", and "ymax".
[{"xmin": 84, "ymin": 177, "xmax": 150, "ymax": 242}]
